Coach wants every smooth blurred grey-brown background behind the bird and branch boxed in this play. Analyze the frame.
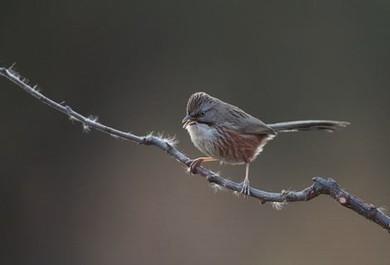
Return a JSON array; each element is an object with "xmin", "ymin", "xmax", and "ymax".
[{"xmin": 0, "ymin": 0, "xmax": 390, "ymax": 265}]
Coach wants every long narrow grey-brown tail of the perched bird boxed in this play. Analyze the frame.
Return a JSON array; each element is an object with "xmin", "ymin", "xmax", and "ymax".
[{"xmin": 268, "ymin": 120, "xmax": 349, "ymax": 132}]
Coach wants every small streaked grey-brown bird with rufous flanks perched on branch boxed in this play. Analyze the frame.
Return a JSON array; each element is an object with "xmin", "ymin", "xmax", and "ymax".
[{"xmin": 182, "ymin": 92, "xmax": 349, "ymax": 195}]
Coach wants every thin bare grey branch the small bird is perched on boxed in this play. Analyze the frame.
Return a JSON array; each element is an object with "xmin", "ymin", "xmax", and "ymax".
[{"xmin": 0, "ymin": 63, "xmax": 390, "ymax": 232}]
